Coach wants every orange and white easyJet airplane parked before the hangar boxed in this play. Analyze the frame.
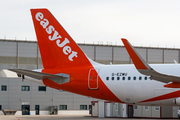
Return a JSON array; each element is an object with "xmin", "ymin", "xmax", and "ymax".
[{"xmin": 4, "ymin": 8, "xmax": 180, "ymax": 106}]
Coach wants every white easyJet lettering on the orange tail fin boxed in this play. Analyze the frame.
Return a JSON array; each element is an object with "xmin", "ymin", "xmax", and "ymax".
[{"xmin": 35, "ymin": 12, "xmax": 77, "ymax": 61}]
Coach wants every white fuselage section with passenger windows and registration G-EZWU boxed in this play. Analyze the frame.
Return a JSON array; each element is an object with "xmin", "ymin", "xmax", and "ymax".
[{"xmin": 95, "ymin": 64, "xmax": 180, "ymax": 105}]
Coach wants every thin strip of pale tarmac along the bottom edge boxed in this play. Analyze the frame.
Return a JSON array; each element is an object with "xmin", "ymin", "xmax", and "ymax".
[{"xmin": 0, "ymin": 115, "xmax": 179, "ymax": 120}]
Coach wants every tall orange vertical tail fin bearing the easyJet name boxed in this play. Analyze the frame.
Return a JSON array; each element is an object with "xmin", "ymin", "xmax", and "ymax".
[{"xmin": 31, "ymin": 9, "xmax": 91, "ymax": 68}]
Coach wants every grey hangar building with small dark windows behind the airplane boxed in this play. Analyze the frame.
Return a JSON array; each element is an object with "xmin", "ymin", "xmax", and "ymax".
[{"xmin": 0, "ymin": 39, "xmax": 180, "ymax": 116}]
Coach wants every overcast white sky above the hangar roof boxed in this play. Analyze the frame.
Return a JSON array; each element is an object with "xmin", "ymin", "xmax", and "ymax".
[{"xmin": 0, "ymin": 0, "xmax": 180, "ymax": 48}]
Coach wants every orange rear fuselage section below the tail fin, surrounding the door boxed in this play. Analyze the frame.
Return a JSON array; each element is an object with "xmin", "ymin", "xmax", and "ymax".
[{"xmin": 43, "ymin": 68, "xmax": 122, "ymax": 103}]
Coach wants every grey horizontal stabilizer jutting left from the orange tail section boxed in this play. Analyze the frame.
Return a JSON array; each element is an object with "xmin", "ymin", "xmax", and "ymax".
[{"xmin": 8, "ymin": 69, "xmax": 69, "ymax": 84}]
